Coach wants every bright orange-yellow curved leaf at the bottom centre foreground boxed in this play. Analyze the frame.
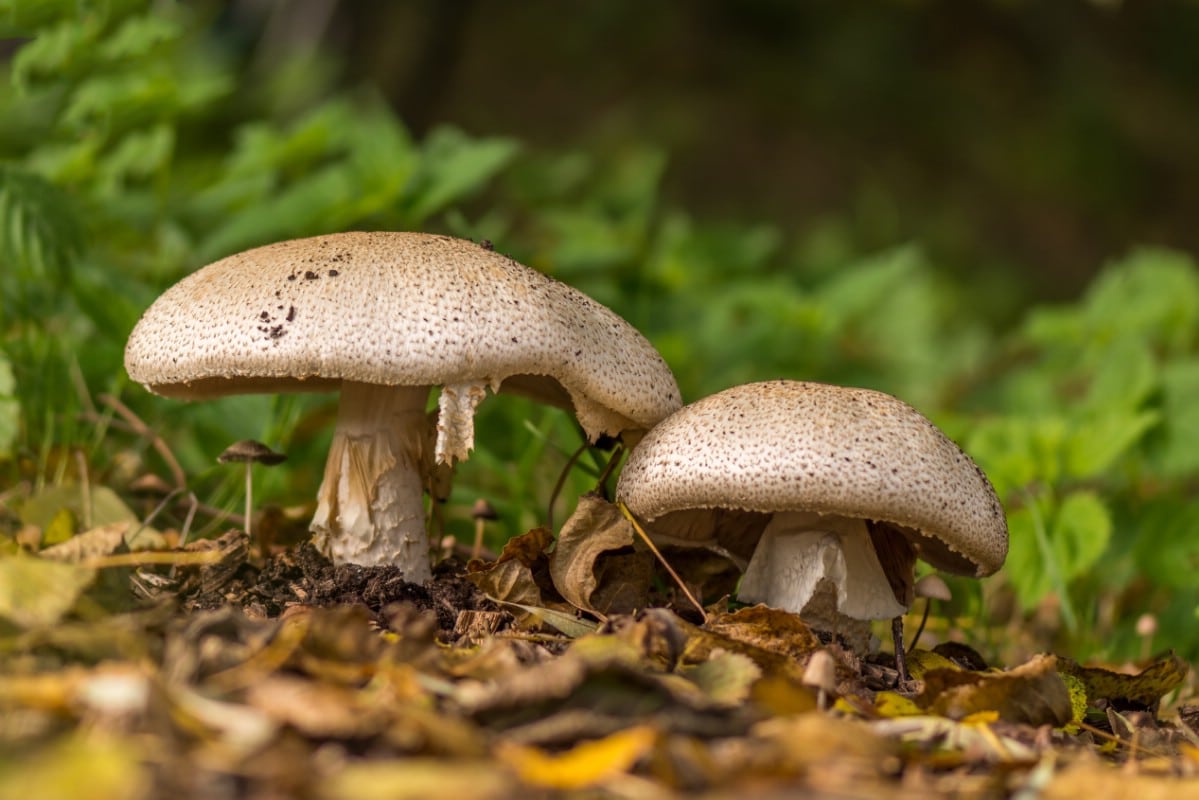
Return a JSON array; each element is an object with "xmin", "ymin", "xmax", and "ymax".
[{"xmin": 496, "ymin": 726, "xmax": 658, "ymax": 790}]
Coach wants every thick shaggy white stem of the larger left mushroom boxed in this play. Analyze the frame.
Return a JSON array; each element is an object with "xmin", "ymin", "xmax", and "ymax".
[{"xmin": 312, "ymin": 381, "xmax": 432, "ymax": 583}]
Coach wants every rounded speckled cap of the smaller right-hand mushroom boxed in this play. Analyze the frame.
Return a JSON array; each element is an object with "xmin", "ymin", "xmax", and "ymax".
[{"xmin": 616, "ymin": 380, "xmax": 1007, "ymax": 576}]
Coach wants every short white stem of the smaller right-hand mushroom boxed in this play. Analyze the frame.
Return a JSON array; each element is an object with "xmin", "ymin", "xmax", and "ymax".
[{"xmin": 737, "ymin": 511, "xmax": 908, "ymax": 622}]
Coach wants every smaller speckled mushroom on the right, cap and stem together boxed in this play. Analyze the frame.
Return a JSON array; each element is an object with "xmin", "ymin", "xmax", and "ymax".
[{"xmin": 616, "ymin": 380, "xmax": 1007, "ymax": 649}]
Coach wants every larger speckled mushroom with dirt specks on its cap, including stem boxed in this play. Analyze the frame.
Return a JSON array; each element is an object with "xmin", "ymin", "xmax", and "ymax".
[{"xmin": 125, "ymin": 233, "xmax": 680, "ymax": 582}]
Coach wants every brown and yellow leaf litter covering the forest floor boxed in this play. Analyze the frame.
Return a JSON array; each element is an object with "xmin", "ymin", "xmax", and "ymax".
[{"xmin": 0, "ymin": 491, "xmax": 1199, "ymax": 800}]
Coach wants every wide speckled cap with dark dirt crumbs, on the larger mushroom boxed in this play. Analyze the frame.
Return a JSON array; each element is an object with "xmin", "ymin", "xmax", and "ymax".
[{"xmin": 125, "ymin": 233, "xmax": 680, "ymax": 439}]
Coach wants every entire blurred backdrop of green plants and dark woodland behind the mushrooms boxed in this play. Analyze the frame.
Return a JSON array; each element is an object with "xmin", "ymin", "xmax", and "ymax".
[{"xmin": 7, "ymin": 0, "xmax": 1199, "ymax": 658}]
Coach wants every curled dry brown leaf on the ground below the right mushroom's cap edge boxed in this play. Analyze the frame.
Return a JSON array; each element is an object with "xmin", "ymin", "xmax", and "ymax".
[{"xmin": 917, "ymin": 655, "xmax": 1073, "ymax": 727}]
